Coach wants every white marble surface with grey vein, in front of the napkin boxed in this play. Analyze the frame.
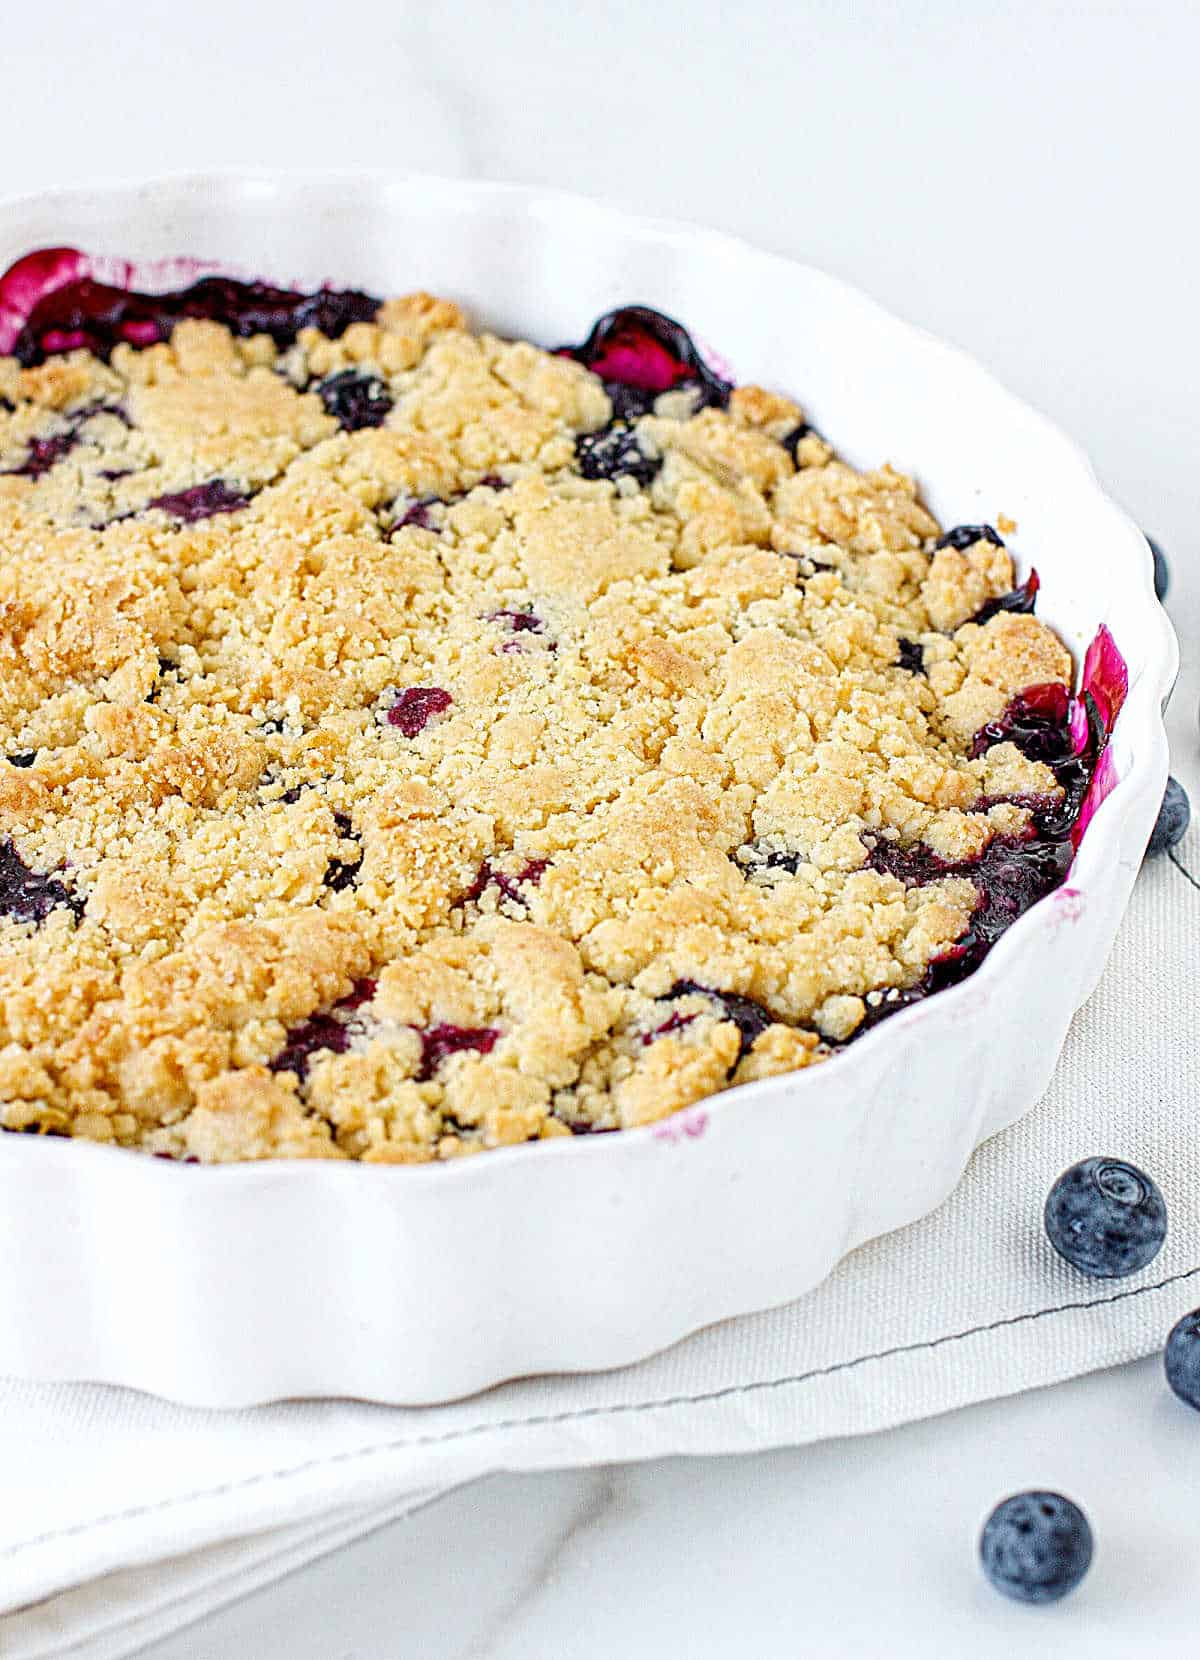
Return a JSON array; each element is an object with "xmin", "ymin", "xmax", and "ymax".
[{"xmin": 143, "ymin": 1361, "xmax": 1200, "ymax": 1660}]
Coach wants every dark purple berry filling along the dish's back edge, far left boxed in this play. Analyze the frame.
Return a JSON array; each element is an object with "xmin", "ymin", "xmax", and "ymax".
[{"xmin": 13, "ymin": 277, "xmax": 380, "ymax": 367}]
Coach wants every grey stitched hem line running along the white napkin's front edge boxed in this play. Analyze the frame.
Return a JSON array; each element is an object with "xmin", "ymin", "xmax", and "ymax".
[{"xmin": 0, "ymin": 1265, "xmax": 1200, "ymax": 1560}]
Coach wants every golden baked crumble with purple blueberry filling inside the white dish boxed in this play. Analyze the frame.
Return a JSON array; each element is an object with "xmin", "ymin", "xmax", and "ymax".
[{"xmin": 0, "ymin": 249, "xmax": 1125, "ymax": 1162}]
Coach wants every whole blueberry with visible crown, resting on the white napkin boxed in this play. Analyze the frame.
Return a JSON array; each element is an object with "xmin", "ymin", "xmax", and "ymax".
[{"xmin": 1046, "ymin": 1159, "xmax": 1167, "ymax": 1280}]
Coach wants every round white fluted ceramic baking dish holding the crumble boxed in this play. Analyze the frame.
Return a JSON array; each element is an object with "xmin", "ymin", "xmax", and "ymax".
[{"xmin": 0, "ymin": 173, "xmax": 1177, "ymax": 1406}]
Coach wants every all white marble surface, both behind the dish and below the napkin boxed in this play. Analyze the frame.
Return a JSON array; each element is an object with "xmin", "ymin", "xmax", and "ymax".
[{"xmin": 0, "ymin": 0, "xmax": 1200, "ymax": 1660}]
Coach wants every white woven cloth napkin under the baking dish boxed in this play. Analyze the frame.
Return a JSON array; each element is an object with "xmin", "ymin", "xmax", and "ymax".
[{"xmin": 0, "ymin": 618, "xmax": 1200, "ymax": 1660}]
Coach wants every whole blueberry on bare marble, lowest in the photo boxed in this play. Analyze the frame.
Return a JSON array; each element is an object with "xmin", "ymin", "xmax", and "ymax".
[{"xmin": 979, "ymin": 1492, "xmax": 1092, "ymax": 1602}]
